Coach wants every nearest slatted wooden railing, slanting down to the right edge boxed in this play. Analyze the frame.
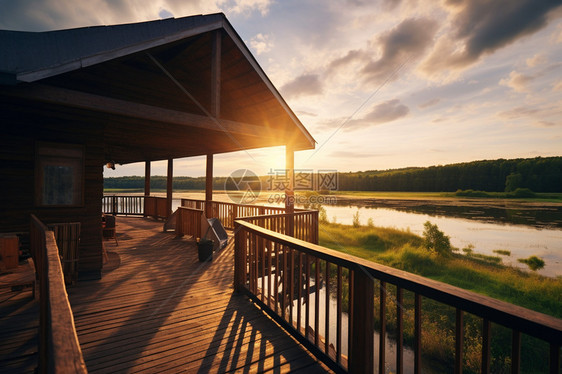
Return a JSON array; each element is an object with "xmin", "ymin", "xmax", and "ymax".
[{"xmin": 234, "ymin": 220, "xmax": 562, "ymax": 374}]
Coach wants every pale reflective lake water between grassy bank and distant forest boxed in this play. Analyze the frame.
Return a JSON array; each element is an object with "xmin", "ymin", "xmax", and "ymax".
[{"xmin": 302, "ymin": 201, "xmax": 562, "ymax": 276}]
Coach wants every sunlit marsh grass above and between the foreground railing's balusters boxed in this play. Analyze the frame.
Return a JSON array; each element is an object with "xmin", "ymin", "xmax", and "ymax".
[{"xmin": 320, "ymin": 222, "xmax": 562, "ymax": 373}]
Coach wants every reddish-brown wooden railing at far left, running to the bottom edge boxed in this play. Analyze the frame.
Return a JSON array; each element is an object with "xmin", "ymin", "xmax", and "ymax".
[{"xmin": 30, "ymin": 215, "xmax": 87, "ymax": 373}]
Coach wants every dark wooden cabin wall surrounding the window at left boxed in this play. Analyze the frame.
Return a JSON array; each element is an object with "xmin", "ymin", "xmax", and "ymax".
[{"xmin": 0, "ymin": 95, "xmax": 104, "ymax": 280}]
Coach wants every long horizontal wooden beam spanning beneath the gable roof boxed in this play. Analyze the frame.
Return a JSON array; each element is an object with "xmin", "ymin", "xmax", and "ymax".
[{"xmin": 0, "ymin": 84, "xmax": 276, "ymax": 138}]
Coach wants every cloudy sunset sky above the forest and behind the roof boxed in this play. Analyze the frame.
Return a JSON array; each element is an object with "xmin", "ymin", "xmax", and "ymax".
[{"xmin": 0, "ymin": 0, "xmax": 562, "ymax": 177}]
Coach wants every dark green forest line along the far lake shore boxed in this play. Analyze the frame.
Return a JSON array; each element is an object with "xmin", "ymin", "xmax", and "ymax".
[{"xmin": 104, "ymin": 157, "xmax": 562, "ymax": 192}]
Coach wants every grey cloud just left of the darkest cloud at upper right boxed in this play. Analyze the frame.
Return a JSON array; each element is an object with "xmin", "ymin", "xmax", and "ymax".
[{"xmin": 361, "ymin": 18, "xmax": 437, "ymax": 84}]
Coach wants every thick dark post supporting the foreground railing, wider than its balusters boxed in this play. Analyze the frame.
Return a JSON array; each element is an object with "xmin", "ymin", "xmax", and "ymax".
[{"xmin": 348, "ymin": 269, "xmax": 375, "ymax": 374}]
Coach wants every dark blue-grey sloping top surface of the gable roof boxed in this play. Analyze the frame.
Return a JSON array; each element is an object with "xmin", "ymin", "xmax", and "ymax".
[{"xmin": 0, "ymin": 13, "xmax": 223, "ymax": 83}]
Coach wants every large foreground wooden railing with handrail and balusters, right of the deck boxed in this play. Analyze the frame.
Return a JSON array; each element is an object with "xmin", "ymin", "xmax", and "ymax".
[{"xmin": 235, "ymin": 219, "xmax": 562, "ymax": 373}]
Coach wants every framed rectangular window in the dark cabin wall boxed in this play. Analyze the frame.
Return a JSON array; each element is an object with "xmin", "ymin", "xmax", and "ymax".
[{"xmin": 35, "ymin": 144, "xmax": 84, "ymax": 207}]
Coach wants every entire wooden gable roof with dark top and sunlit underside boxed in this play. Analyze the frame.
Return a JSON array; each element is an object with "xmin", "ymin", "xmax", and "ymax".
[{"xmin": 0, "ymin": 14, "xmax": 315, "ymax": 164}]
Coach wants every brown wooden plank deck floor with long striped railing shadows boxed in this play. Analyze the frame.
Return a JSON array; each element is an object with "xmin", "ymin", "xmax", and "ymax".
[{"xmin": 69, "ymin": 217, "xmax": 328, "ymax": 373}]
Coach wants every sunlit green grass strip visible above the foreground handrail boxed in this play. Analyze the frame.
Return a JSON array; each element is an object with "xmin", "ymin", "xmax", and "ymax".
[{"xmin": 320, "ymin": 222, "xmax": 562, "ymax": 318}]
